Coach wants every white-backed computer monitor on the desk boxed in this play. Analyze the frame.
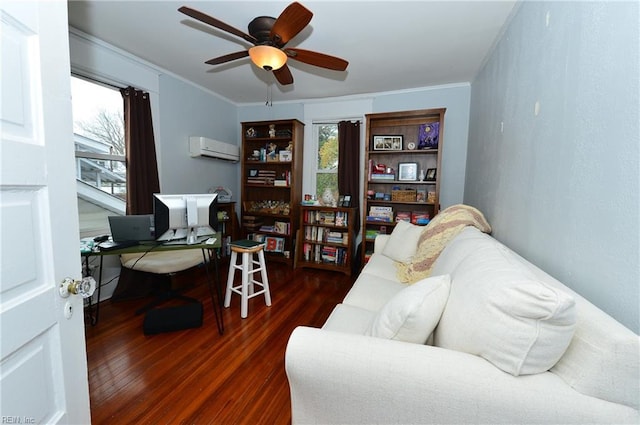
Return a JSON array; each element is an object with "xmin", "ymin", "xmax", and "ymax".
[{"xmin": 153, "ymin": 193, "xmax": 218, "ymax": 245}]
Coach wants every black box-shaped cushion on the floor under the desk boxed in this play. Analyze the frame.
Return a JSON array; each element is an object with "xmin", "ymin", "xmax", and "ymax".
[{"xmin": 142, "ymin": 302, "xmax": 202, "ymax": 335}]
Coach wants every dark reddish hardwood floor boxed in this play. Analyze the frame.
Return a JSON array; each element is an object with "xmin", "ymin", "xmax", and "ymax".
[{"xmin": 86, "ymin": 262, "xmax": 354, "ymax": 424}]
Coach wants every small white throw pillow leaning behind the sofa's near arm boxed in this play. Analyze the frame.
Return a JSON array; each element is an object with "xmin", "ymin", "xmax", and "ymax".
[{"xmin": 367, "ymin": 275, "xmax": 451, "ymax": 344}]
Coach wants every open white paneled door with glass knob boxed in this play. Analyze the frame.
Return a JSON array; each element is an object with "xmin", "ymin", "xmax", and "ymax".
[{"xmin": 0, "ymin": 0, "xmax": 91, "ymax": 424}]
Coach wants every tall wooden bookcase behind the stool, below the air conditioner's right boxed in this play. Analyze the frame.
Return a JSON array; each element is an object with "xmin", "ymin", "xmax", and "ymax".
[{"xmin": 241, "ymin": 119, "xmax": 304, "ymax": 265}]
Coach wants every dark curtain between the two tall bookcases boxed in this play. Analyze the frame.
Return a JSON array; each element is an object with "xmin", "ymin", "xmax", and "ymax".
[{"xmin": 338, "ymin": 121, "xmax": 360, "ymax": 229}]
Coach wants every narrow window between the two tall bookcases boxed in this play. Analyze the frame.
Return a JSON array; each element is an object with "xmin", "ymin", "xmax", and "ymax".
[{"xmin": 313, "ymin": 123, "xmax": 339, "ymax": 206}]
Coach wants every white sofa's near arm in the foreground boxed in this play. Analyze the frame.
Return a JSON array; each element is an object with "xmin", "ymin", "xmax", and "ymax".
[{"xmin": 285, "ymin": 327, "xmax": 638, "ymax": 424}]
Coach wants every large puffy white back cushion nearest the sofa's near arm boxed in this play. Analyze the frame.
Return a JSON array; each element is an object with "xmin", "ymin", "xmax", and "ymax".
[{"xmin": 435, "ymin": 236, "xmax": 576, "ymax": 376}]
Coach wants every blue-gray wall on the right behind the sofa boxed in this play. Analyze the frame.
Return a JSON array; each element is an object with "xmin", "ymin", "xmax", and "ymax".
[{"xmin": 464, "ymin": 2, "xmax": 640, "ymax": 333}]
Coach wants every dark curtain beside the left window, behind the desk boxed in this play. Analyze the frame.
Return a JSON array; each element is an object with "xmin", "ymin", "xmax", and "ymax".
[{"xmin": 120, "ymin": 87, "xmax": 160, "ymax": 215}]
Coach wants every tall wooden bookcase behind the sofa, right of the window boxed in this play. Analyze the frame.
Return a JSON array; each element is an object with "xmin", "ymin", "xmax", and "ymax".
[{"xmin": 362, "ymin": 108, "xmax": 446, "ymax": 264}]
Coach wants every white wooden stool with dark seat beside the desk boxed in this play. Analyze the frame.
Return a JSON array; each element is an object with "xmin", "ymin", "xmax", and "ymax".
[{"xmin": 224, "ymin": 239, "xmax": 271, "ymax": 319}]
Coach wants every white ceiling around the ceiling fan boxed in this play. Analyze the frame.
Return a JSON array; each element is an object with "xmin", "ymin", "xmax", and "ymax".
[{"xmin": 69, "ymin": 0, "xmax": 516, "ymax": 103}]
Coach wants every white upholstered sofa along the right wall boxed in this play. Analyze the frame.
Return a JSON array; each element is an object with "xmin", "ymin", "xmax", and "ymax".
[{"xmin": 285, "ymin": 227, "xmax": 640, "ymax": 424}]
